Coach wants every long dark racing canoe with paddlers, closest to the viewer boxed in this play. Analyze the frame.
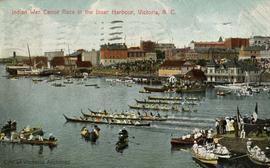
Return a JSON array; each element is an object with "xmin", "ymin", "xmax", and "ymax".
[{"xmin": 63, "ymin": 114, "xmax": 150, "ymax": 126}]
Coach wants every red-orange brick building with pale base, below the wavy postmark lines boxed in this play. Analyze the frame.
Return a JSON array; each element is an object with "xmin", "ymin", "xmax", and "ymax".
[{"xmin": 100, "ymin": 43, "xmax": 128, "ymax": 66}]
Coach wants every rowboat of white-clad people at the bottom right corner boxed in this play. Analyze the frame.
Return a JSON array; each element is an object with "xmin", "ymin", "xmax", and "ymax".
[{"xmin": 247, "ymin": 141, "xmax": 270, "ymax": 167}]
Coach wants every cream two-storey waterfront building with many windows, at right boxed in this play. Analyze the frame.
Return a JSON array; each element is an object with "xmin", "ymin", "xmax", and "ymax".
[{"xmin": 206, "ymin": 60, "xmax": 259, "ymax": 83}]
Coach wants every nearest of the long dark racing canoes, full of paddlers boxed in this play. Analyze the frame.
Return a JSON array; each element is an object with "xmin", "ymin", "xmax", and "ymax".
[{"xmin": 63, "ymin": 114, "xmax": 150, "ymax": 126}]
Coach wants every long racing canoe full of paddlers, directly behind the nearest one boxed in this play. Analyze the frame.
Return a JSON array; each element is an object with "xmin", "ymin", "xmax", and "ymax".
[{"xmin": 81, "ymin": 112, "xmax": 167, "ymax": 121}]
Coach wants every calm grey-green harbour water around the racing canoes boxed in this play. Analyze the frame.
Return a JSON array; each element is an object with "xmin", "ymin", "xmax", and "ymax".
[{"xmin": 0, "ymin": 65, "xmax": 270, "ymax": 168}]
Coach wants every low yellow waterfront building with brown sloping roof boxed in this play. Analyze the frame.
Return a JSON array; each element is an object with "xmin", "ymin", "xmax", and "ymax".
[{"xmin": 158, "ymin": 60, "xmax": 196, "ymax": 77}]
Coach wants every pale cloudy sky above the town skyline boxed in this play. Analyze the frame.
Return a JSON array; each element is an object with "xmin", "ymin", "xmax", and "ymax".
[{"xmin": 0, "ymin": 0, "xmax": 270, "ymax": 58}]
